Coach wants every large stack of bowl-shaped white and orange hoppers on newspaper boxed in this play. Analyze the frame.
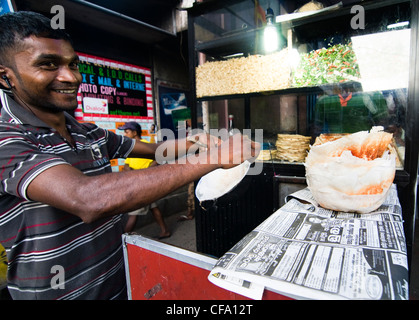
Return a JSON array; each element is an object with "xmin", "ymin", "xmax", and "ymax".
[{"xmin": 305, "ymin": 127, "xmax": 396, "ymax": 213}]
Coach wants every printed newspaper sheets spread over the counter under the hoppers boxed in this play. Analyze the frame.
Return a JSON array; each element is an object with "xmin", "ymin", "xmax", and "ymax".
[{"xmin": 208, "ymin": 185, "xmax": 409, "ymax": 300}]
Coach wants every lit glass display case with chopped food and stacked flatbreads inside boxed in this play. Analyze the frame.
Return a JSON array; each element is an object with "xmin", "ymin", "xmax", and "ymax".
[{"xmin": 188, "ymin": 0, "xmax": 419, "ymax": 260}]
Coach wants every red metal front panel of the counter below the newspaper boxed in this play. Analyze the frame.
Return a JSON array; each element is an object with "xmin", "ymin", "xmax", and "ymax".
[{"xmin": 123, "ymin": 235, "xmax": 290, "ymax": 300}]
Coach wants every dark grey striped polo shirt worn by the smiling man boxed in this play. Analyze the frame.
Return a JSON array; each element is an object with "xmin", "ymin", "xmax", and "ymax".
[{"xmin": 0, "ymin": 90, "xmax": 134, "ymax": 299}]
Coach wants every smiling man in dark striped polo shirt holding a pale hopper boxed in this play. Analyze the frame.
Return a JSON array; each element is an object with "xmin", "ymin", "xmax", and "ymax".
[{"xmin": 0, "ymin": 12, "xmax": 259, "ymax": 299}]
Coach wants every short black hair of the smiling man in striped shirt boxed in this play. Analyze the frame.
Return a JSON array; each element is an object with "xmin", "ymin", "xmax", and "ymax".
[{"xmin": 0, "ymin": 11, "xmax": 72, "ymax": 65}]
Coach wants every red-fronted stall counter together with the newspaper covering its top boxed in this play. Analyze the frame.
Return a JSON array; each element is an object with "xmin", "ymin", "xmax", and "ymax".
[{"xmin": 123, "ymin": 185, "xmax": 409, "ymax": 300}]
